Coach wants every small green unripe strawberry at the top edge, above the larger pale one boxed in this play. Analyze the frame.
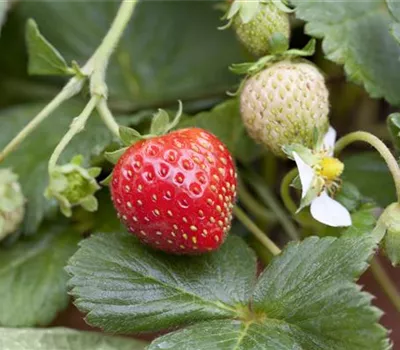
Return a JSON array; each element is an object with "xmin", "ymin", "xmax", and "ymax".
[{"xmin": 232, "ymin": 2, "xmax": 290, "ymax": 57}]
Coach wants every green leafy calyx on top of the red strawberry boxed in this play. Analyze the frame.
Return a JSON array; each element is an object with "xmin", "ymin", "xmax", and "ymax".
[{"xmin": 103, "ymin": 101, "xmax": 183, "ymax": 165}]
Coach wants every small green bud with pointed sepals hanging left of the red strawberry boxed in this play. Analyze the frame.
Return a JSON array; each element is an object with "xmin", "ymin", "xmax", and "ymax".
[{"xmin": 45, "ymin": 155, "xmax": 101, "ymax": 217}]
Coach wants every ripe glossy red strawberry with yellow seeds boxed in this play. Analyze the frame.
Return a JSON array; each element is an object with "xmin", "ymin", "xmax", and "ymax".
[{"xmin": 111, "ymin": 128, "xmax": 236, "ymax": 254}]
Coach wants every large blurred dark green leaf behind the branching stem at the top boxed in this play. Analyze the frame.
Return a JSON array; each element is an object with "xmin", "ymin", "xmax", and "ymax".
[{"xmin": 16, "ymin": 0, "xmax": 244, "ymax": 110}]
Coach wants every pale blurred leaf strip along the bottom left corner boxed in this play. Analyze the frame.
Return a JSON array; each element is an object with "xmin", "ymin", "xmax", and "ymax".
[{"xmin": 0, "ymin": 328, "xmax": 147, "ymax": 350}]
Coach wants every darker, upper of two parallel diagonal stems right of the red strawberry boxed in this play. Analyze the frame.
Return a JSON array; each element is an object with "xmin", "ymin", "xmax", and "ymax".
[{"xmin": 245, "ymin": 171, "xmax": 299, "ymax": 241}]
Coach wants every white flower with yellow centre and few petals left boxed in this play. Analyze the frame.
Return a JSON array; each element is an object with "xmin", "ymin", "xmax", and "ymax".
[{"xmin": 285, "ymin": 127, "xmax": 351, "ymax": 227}]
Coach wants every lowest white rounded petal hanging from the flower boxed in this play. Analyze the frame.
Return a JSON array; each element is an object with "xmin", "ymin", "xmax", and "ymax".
[{"xmin": 311, "ymin": 191, "xmax": 351, "ymax": 227}]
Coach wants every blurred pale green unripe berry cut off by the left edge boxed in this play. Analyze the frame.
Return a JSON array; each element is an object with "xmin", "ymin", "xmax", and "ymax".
[{"xmin": 0, "ymin": 169, "xmax": 25, "ymax": 240}]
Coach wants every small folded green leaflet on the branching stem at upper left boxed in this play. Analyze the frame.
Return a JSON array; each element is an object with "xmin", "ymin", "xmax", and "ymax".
[{"xmin": 26, "ymin": 19, "xmax": 74, "ymax": 75}]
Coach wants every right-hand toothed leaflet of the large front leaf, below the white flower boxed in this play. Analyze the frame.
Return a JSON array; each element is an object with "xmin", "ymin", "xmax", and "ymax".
[{"xmin": 252, "ymin": 233, "xmax": 388, "ymax": 350}]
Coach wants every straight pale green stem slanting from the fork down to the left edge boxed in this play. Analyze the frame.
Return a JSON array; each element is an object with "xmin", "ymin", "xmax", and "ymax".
[{"xmin": 0, "ymin": 77, "xmax": 85, "ymax": 162}]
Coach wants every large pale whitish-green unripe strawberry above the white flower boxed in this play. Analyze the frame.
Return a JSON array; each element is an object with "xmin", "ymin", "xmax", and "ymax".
[{"xmin": 240, "ymin": 60, "xmax": 329, "ymax": 157}]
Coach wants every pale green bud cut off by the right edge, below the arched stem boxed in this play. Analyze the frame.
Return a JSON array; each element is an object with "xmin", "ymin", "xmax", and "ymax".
[{"xmin": 379, "ymin": 203, "xmax": 400, "ymax": 266}]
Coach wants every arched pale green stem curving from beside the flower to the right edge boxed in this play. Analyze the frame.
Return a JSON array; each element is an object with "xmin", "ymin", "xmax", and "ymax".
[{"xmin": 335, "ymin": 131, "xmax": 400, "ymax": 202}]
